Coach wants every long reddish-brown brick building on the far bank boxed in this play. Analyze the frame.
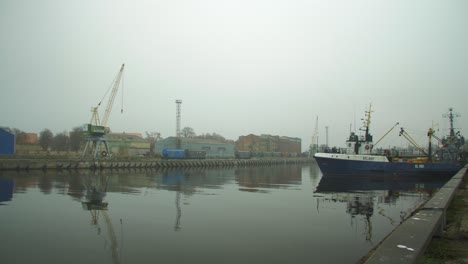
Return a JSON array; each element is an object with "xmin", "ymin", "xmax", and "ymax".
[{"xmin": 236, "ymin": 134, "xmax": 301, "ymax": 156}]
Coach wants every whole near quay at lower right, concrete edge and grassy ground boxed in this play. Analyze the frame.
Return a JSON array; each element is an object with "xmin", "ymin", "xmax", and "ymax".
[{"xmin": 359, "ymin": 166, "xmax": 468, "ymax": 264}]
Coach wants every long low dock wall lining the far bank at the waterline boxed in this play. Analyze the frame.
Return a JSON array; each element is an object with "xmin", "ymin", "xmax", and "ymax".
[{"xmin": 0, "ymin": 158, "xmax": 312, "ymax": 170}]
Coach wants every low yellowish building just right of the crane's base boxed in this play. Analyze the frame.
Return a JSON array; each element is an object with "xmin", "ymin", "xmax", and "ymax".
[{"xmin": 106, "ymin": 132, "xmax": 150, "ymax": 156}]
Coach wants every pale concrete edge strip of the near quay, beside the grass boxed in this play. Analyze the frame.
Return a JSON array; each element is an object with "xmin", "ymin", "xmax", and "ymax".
[{"xmin": 364, "ymin": 167, "xmax": 467, "ymax": 264}]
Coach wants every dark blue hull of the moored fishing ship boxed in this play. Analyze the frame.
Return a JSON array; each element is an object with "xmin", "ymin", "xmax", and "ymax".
[{"xmin": 315, "ymin": 157, "xmax": 462, "ymax": 177}]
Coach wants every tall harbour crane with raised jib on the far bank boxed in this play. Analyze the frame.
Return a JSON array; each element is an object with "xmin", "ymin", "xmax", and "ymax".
[{"xmin": 81, "ymin": 64, "xmax": 125, "ymax": 159}]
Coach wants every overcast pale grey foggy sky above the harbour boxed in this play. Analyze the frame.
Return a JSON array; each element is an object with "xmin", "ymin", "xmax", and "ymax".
[{"xmin": 0, "ymin": 0, "xmax": 468, "ymax": 148}]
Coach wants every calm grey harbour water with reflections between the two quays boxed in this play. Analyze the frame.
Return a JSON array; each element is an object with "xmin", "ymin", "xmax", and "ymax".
[{"xmin": 0, "ymin": 163, "xmax": 444, "ymax": 264}]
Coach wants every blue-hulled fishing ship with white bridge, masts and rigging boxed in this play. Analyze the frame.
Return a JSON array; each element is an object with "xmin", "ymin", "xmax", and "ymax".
[{"xmin": 314, "ymin": 106, "xmax": 464, "ymax": 177}]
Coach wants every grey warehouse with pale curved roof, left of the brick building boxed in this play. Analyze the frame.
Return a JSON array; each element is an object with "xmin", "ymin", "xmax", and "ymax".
[{"xmin": 154, "ymin": 137, "xmax": 234, "ymax": 158}]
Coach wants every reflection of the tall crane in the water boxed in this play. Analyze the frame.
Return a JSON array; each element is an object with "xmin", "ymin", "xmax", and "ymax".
[{"xmin": 81, "ymin": 174, "xmax": 122, "ymax": 263}]
